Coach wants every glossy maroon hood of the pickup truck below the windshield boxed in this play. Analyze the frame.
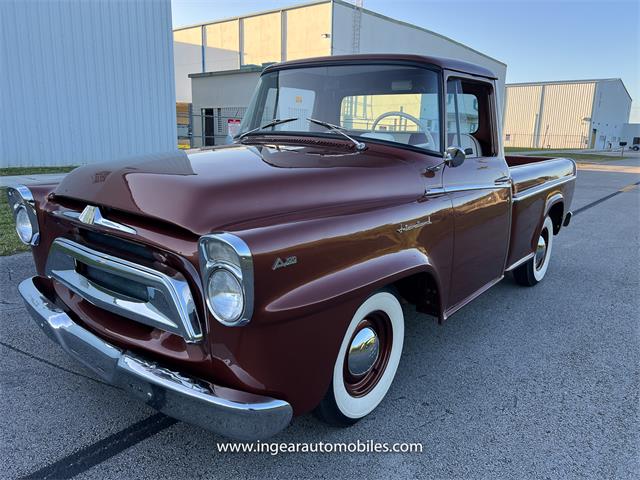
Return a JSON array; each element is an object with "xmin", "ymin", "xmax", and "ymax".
[{"xmin": 54, "ymin": 145, "xmax": 424, "ymax": 235}]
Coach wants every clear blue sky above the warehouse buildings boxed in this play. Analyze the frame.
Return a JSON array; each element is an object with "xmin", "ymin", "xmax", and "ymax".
[{"xmin": 171, "ymin": 0, "xmax": 640, "ymax": 122}]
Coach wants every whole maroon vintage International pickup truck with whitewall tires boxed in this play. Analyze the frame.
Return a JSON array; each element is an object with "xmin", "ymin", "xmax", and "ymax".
[{"xmin": 8, "ymin": 55, "xmax": 576, "ymax": 439}]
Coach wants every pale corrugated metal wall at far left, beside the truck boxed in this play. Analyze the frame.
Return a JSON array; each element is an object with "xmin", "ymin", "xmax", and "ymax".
[{"xmin": 0, "ymin": 0, "xmax": 176, "ymax": 167}]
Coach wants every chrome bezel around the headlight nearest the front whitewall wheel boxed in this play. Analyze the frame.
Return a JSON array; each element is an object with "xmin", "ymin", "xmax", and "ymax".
[{"xmin": 198, "ymin": 233, "xmax": 253, "ymax": 327}]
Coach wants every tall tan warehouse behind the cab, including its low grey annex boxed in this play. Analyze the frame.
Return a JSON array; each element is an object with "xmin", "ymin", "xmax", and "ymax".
[{"xmin": 173, "ymin": 0, "xmax": 506, "ymax": 147}]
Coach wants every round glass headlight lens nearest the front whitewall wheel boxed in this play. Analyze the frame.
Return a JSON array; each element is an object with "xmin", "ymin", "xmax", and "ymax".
[{"xmin": 207, "ymin": 268, "xmax": 244, "ymax": 324}]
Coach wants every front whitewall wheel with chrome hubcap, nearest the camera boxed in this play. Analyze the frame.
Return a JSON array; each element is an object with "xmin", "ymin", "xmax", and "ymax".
[{"xmin": 316, "ymin": 291, "xmax": 404, "ymax": 426}]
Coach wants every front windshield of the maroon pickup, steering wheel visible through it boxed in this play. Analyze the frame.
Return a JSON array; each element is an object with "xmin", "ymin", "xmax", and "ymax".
[{"xmin": 240, "ymin": 65, "xmax": 441, "ymax": 153}]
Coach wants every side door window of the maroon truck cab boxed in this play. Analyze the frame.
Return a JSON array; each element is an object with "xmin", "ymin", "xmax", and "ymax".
[{"xmin": 446, "ymin": 78, "xmax": 495, "ymax": 157}]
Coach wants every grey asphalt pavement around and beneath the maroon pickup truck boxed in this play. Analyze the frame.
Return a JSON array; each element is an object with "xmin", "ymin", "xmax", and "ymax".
[{"xmin": 0, "ymin": 160, "xmax": 640, "ymax": 479}]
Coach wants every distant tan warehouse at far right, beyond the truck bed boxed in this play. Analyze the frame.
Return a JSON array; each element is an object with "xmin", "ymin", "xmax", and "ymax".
[{"xmin": 503, "ymin": 78, "xmax": 631, "ymax": 149}]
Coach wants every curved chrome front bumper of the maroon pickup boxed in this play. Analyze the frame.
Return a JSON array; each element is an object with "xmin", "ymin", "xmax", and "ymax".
[{"xmin": 18, "ymin": 278, "xmax": 293, "ymax": 440}]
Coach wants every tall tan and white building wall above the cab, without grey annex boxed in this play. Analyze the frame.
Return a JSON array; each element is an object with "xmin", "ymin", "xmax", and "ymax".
[{"xmin": 174, "ymin": 0, "xmax": 507, "ymax": 112}]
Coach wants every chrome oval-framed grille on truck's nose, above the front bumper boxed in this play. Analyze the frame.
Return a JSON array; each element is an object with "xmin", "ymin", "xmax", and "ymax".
[{"xmin": 46, "ymin": 238, "xmax": 202, "ymax": 343}]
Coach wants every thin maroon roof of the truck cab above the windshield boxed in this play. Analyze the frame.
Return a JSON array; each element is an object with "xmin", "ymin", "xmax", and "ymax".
[{"xmin": 263, "ymin": 53, "xmax": 498, "ymax": 79}]
